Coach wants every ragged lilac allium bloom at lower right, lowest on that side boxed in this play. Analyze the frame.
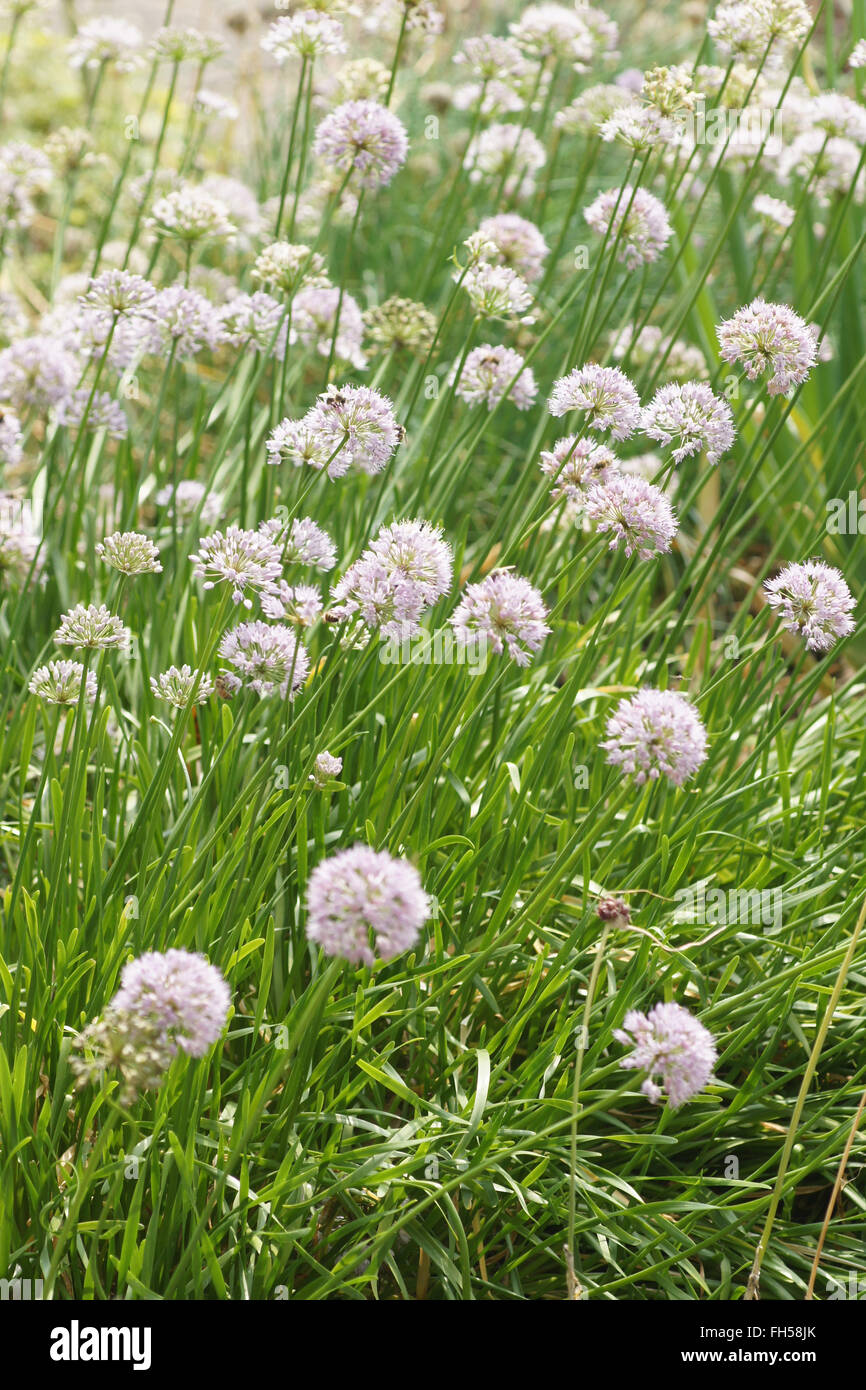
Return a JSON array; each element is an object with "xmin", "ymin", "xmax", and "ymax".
[{"xmin": 613, "ymin": 1004, "xmax": 719, "ymax": 1109}]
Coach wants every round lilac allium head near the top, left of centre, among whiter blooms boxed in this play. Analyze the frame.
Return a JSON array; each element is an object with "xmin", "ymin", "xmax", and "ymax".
[{"xmin": 313, "ymin": 101, "xmax": 409, "ymax": 188}]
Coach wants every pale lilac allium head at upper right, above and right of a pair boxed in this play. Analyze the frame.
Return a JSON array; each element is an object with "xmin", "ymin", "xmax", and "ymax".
[{"xmin": 716, "ymin": 296, "xmax": 817, "ymax": 396}]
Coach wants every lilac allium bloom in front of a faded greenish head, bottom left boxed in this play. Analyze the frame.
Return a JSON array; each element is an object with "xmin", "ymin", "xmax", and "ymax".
[{"xmin": 110, "ymin": 949, "xmax": 231, "ymax": 1056}]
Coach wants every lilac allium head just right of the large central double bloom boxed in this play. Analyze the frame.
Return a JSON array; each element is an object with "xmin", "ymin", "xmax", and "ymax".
[{"xmin": 450, "ymin": 570, "xmax": 550, "ymax": 666}]
